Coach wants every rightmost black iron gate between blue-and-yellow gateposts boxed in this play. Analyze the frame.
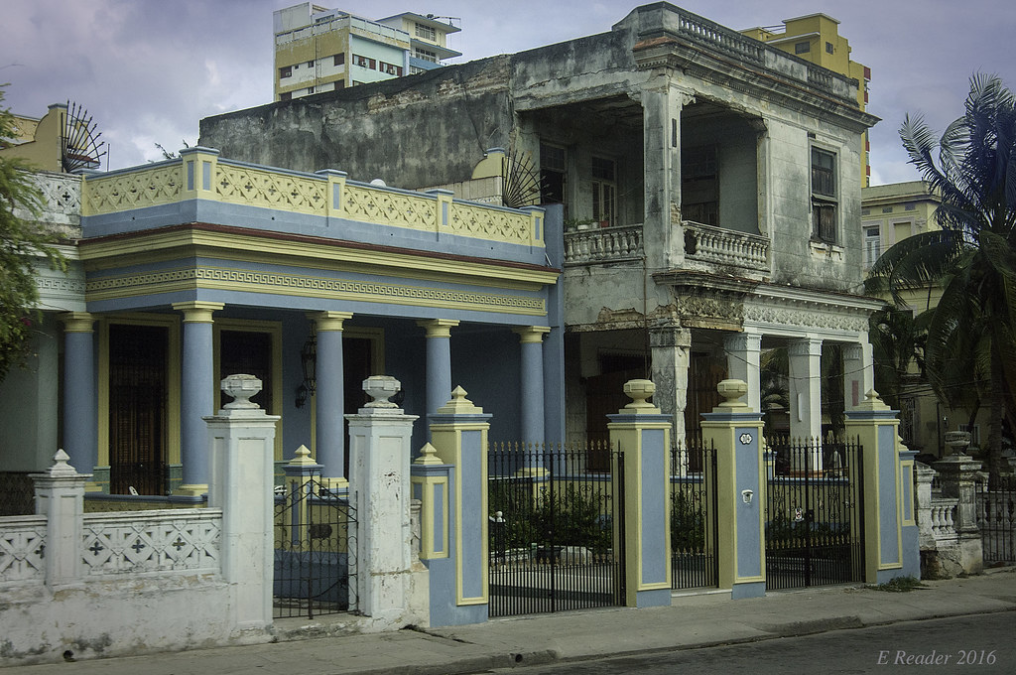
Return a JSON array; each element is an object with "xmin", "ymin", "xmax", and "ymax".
[{"xmin": 765, "ymin": 440, "xmax": 865, "ymax": 591}]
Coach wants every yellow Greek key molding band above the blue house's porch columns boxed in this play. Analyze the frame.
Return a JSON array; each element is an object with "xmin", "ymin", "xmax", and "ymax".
[{"xmin": 86, "ymin": 267, "xmax": 547, "ymax": 315}]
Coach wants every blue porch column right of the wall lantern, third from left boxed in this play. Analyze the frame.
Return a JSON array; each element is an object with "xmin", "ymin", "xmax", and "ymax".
[{"xmin": 308, "ymin": 312, "xmax": 353, "ymax": 489}]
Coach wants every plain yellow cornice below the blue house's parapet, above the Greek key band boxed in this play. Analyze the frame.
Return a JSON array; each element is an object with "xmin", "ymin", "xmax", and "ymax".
[{"xmin": 80, "ymin": 229, "xmax": 559, "ymax": 290}]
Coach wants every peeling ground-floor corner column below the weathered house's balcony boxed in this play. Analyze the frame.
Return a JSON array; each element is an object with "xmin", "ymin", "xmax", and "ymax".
[{"xmin": 649, "ymin": 325, "xmax": 692, "ymax": 447}]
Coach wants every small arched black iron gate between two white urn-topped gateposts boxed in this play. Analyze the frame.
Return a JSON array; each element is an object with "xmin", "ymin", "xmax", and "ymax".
[{"xmin": 272, "ymin": 477, "xmax": 357, "ymax": 619}]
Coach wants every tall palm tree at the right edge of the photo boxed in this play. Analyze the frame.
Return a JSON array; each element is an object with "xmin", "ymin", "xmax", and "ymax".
[{"xmin": 866, "ymin": 74, "xmax": 1016, "ymax": 476}]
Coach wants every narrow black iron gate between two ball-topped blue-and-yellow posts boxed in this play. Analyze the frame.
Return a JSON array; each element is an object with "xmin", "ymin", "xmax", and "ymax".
[{"xmin": 671, "ymin": 443, "xmax": 719, "ymax": 590}]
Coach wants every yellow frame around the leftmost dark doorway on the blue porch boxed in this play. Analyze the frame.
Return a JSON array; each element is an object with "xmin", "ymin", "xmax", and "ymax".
[{"xmin": 97, "ymin": 313, "xmax": 182, "ymax": 467}]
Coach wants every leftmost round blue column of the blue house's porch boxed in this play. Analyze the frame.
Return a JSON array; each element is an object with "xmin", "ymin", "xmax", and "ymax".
[{"xmin": 60, "ymin": 312, "xmax": 97, "ymax": 491}]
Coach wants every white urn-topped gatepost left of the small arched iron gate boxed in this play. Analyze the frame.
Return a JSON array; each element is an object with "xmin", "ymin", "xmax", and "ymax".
[{"xmin": 203, "ymin": 375, "xmax": 280, "ymax": 634}]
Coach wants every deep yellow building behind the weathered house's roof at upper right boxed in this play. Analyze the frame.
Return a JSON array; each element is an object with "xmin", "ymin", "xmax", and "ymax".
[{"xmin": 741, "ymin": 14, "xmax": 872, "ymax": 187}]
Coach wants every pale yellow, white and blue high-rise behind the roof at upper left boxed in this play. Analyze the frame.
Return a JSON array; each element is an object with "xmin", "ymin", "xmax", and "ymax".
[{"xmin": 273, "ymin": 2, "xmax": 461, "ymax": 101}]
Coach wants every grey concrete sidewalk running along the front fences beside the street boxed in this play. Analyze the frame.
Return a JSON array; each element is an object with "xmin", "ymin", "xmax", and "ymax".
[{"xmin": 0, "ymin": 567, "xmax": 1016, "ymax": 675}]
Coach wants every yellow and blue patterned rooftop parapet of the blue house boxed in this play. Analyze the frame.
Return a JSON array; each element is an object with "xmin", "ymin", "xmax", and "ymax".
[{"xmin": 81, "ymin": 147, "xmax": 544, "ymax": 253}]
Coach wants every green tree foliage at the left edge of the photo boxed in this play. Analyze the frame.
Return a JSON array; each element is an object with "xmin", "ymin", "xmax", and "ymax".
[{"xmin": 0, "ymin": 85, "xmax": 65, "ymax": 380}]
